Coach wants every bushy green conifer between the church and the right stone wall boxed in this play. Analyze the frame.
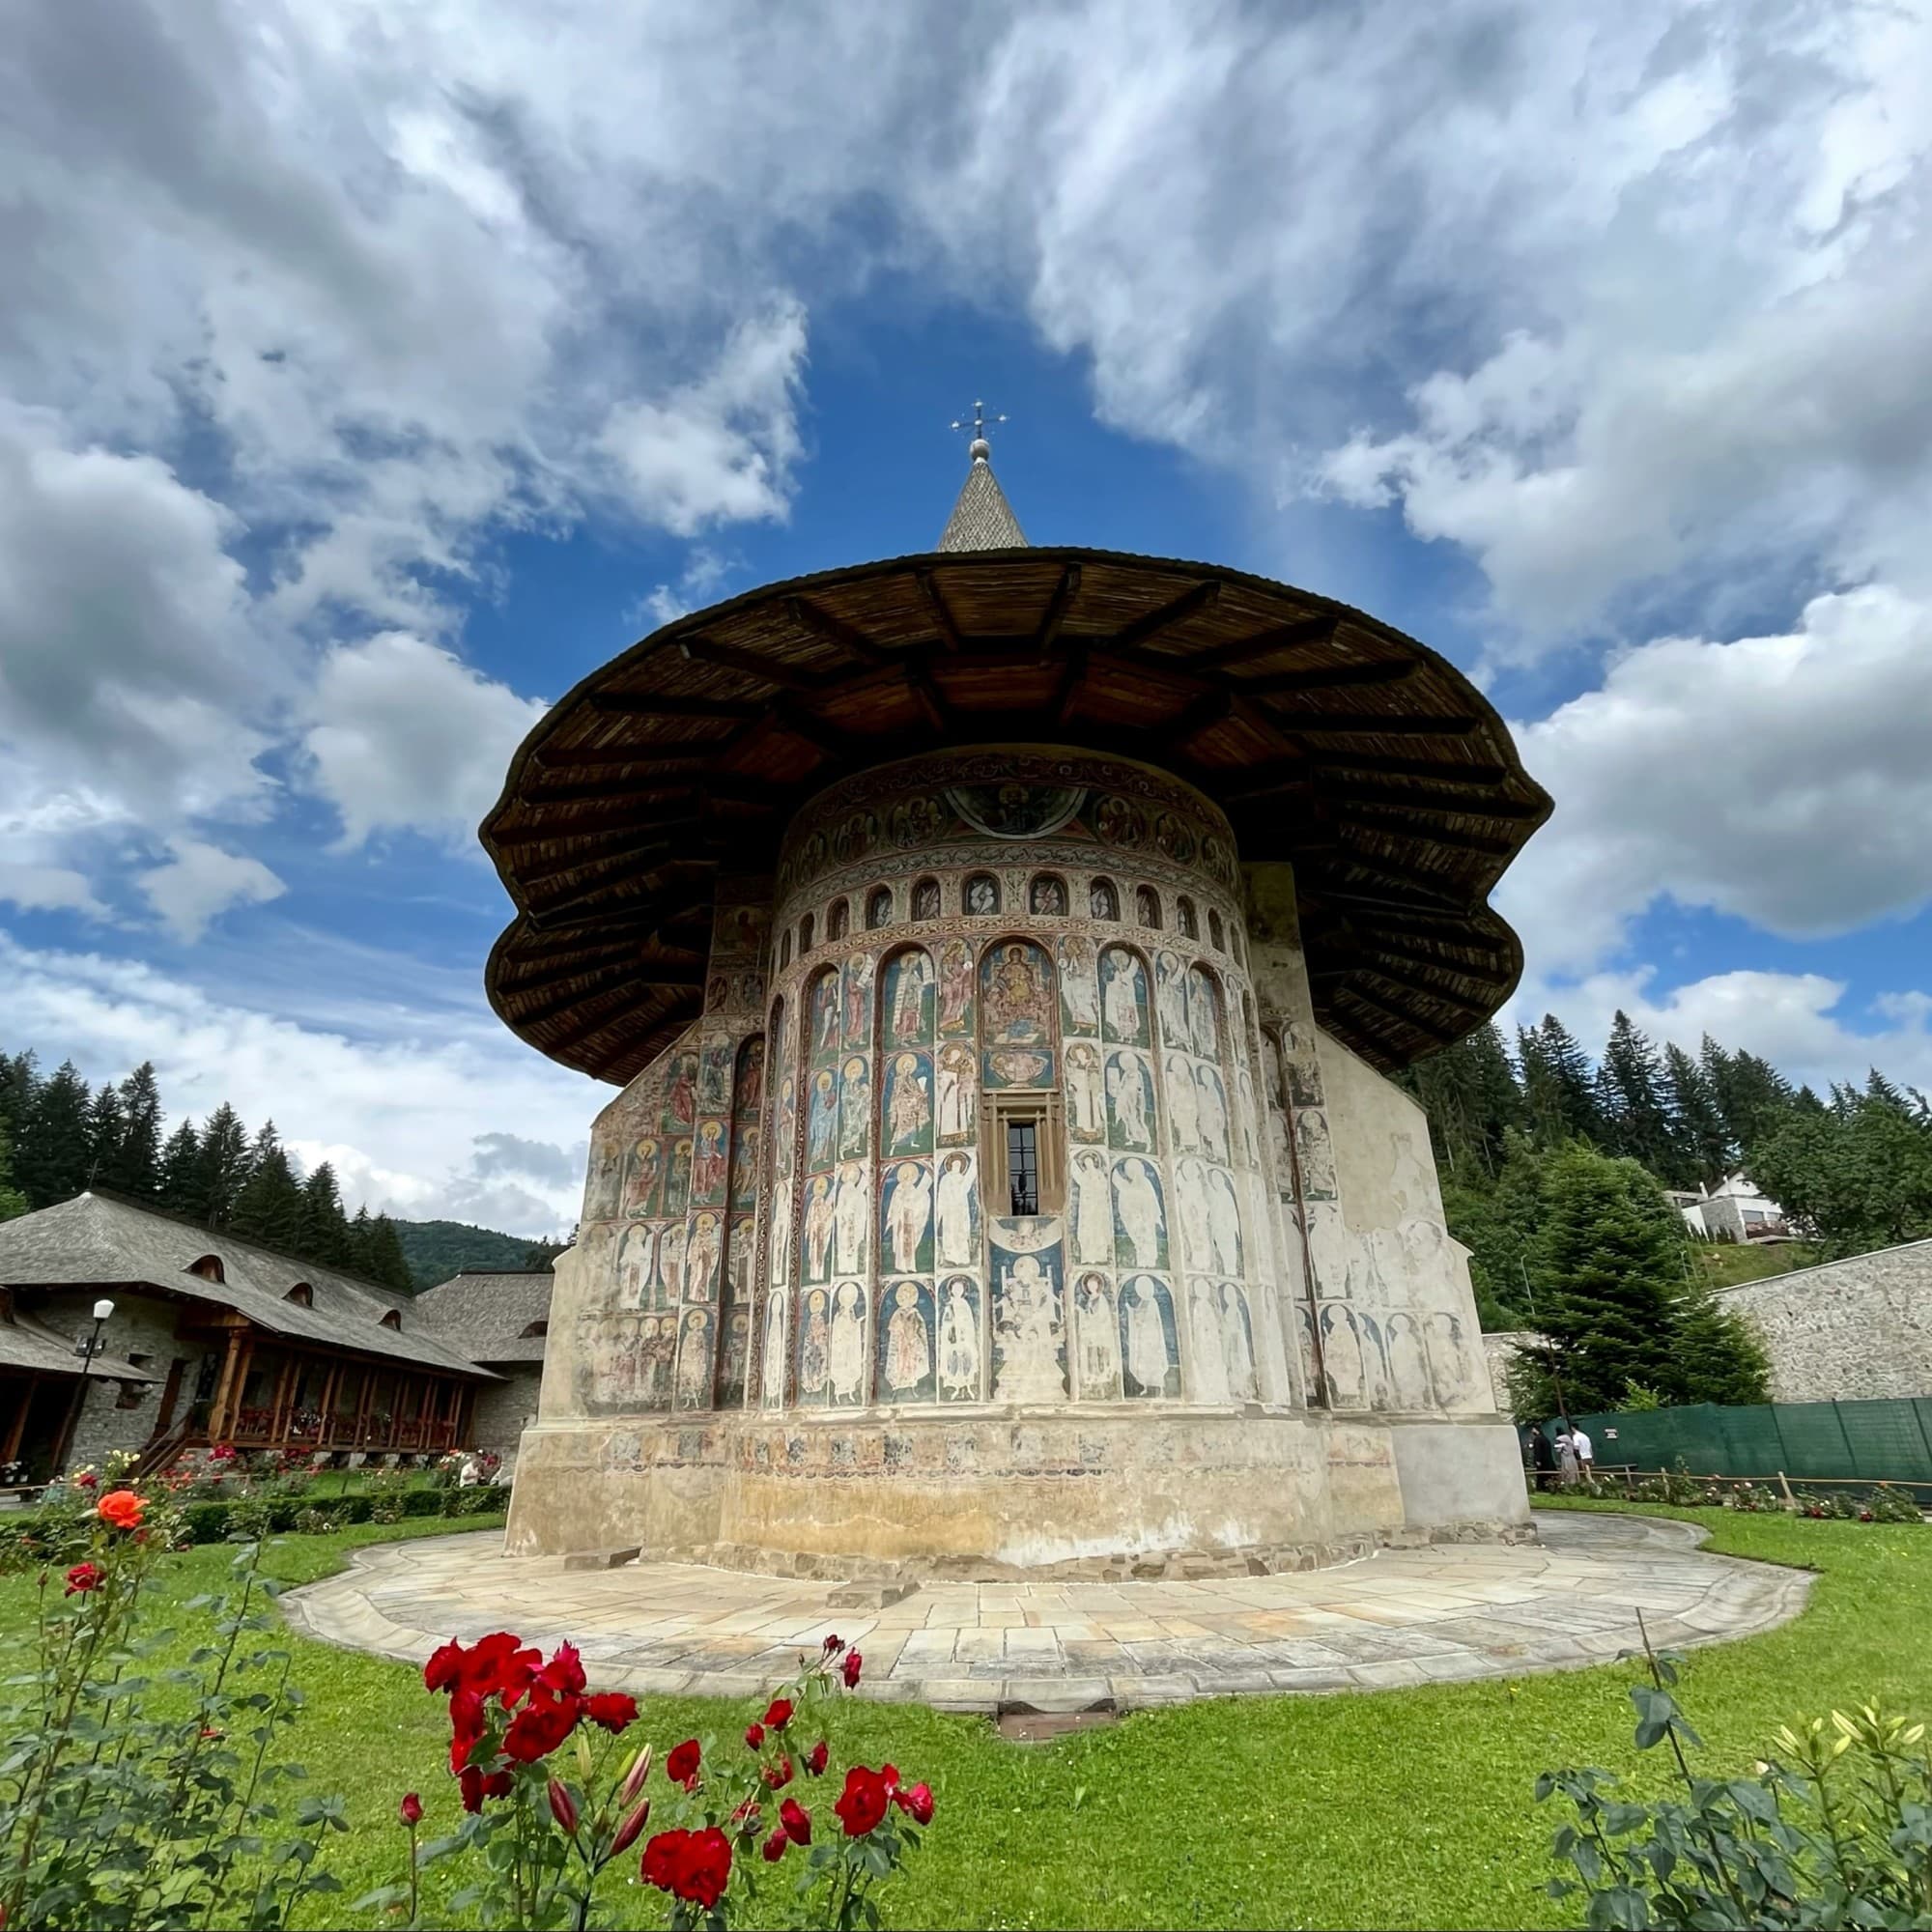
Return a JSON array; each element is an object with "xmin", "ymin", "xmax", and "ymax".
[{"xmin": 1530, "ymin": 1146, "xmax": 1683, "ymax": 1414}]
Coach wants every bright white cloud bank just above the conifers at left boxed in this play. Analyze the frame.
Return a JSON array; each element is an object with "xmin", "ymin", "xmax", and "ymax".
[{"xmin": 0, "ymin": 933, "xmax": 591, "ymax": 1236}]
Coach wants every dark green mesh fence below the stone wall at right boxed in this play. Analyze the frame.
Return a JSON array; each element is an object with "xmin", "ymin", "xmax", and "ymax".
[{"xmin": 1549, "ymin": 1397, "xmax": 1932, "ymax": 1484}]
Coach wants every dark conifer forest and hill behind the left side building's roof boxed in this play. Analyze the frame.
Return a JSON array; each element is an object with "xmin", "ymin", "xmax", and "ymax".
[{"xmin": 0, "ymin": 1053, "xmax": 556, "ymax": 1294}]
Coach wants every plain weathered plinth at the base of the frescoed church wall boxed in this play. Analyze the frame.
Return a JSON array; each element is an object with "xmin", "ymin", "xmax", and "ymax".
[{"xmin": 506, "ymin": 1403, "xmax": 1534, "ymax": 1580}]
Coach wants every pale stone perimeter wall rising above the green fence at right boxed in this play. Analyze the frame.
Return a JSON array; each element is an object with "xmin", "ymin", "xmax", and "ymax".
[{"xmin": 1723, "ymin": 1240, "xmax": 1932, "ymax": 1403}]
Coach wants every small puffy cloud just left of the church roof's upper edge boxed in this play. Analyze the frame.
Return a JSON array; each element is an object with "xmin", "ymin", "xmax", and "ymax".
[{"xmin": 303, "ymin": 632, "xmax": 543, "ymax": 848}]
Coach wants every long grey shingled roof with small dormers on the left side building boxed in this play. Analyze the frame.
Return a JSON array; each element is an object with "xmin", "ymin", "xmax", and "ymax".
[{"xmin": 0, "ymin": 1190, "xmax": 495, "ymax": 1379}]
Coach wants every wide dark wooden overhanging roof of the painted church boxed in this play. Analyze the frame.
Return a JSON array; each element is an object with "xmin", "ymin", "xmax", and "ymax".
[{"xmin": 481, "ymin": 549, "xmax": 1549, "ymax": 1082}]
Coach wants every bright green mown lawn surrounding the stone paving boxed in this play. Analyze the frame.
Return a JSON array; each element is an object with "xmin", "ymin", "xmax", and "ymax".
[{"xmin": 0, "ymin": 1499, "xmax": 1932, "ymax": 1926}]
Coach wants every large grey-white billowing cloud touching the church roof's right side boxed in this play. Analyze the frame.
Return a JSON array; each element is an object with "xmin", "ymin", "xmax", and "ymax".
[{"xmin": 1495, "ymin": 587, "xmax": 1932, "ymax": 972}]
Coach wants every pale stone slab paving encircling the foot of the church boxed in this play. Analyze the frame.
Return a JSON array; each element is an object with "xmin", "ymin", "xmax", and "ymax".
[{"xmin": 282, "ymin": 1511, "xmax": 1810, "ymax": 1712}]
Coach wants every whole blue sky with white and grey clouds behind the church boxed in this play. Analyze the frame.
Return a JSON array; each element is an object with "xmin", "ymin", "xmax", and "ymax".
[{"xmin": 0, "ymin": 0, "xmax": 1932, "ymax": 1233}]
